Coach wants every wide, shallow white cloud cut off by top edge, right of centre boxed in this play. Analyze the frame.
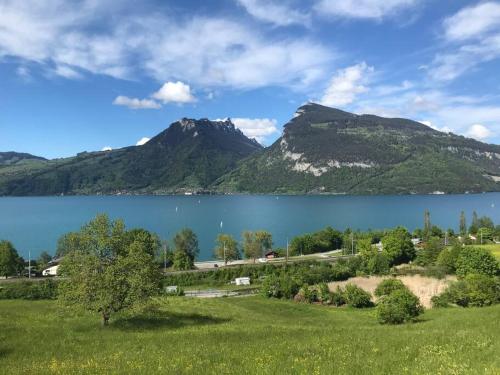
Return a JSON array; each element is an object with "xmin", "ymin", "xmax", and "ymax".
[{"xmin": 316, "ymin": 0, "xmax": 421, "ymax": 19}]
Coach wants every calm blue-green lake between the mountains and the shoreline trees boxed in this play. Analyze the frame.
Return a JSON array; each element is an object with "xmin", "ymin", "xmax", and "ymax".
[{"xmin": 0, "ymin": 193, "xmax": 500, "ymax": 260}]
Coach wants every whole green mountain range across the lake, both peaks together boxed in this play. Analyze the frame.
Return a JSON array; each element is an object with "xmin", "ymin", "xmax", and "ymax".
[{"xmin": 0, "ymin": 103, "xmax": 500, "ymax": 195}]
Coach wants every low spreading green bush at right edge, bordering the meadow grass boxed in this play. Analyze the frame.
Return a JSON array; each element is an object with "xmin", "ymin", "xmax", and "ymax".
[{"xmin": 432, "ymin": 274, "xmax": 500, "ymax": 307}]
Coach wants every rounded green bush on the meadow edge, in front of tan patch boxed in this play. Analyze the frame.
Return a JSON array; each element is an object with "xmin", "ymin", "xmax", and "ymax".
[{"xmin": 377, "ymin": 288, "xmax": 424, "ymax": 324}]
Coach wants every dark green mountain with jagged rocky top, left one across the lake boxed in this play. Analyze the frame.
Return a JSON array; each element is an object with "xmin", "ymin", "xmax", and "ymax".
[{"xmin": 0, "ymin": 119, "xmax": 262, "ymax": 195}]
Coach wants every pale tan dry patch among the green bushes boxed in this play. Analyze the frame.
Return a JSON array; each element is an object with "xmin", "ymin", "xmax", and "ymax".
[{"xmin": 328, "ymin": 275, "xmax": 457, "ymax": 308}]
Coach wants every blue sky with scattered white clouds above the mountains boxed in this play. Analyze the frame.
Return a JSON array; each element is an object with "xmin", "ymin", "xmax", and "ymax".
[{"xmin": 0, "ymin": 0, "xmax": 500, "ymax": 158}]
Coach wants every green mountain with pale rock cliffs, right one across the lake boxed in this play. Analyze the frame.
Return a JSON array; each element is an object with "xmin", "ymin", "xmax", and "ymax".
[{"xmin": 214, "ymin": 103, "xmax": 500, "ymax": 194}]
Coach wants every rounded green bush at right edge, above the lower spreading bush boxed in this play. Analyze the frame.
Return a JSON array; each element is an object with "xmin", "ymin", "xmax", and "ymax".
[{"xmin": 456, "ymin": 247, "xmax": 499, "ymax": 277}]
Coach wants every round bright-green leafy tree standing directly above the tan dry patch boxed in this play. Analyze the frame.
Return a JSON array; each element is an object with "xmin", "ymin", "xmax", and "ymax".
[{"xmin": 382, "ymin": 227, "xmax": 415, "ymax": 265}]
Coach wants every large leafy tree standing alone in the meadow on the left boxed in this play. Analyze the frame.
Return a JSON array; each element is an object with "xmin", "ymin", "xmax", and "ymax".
[{"xmin": 59, "ymin": 215, "xmax": 160, "ymax": 325}]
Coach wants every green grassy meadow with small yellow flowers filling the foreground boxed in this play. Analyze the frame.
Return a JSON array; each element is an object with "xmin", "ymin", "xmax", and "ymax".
[{"xmin": 0, "ymin": 296, "xmax": 500, "ymax": 374}]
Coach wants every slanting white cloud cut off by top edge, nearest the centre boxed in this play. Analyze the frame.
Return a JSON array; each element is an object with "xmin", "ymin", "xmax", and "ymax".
[{"xmin": 237, "ymin": 0, "xmax": 310, "ymax": 26}]
